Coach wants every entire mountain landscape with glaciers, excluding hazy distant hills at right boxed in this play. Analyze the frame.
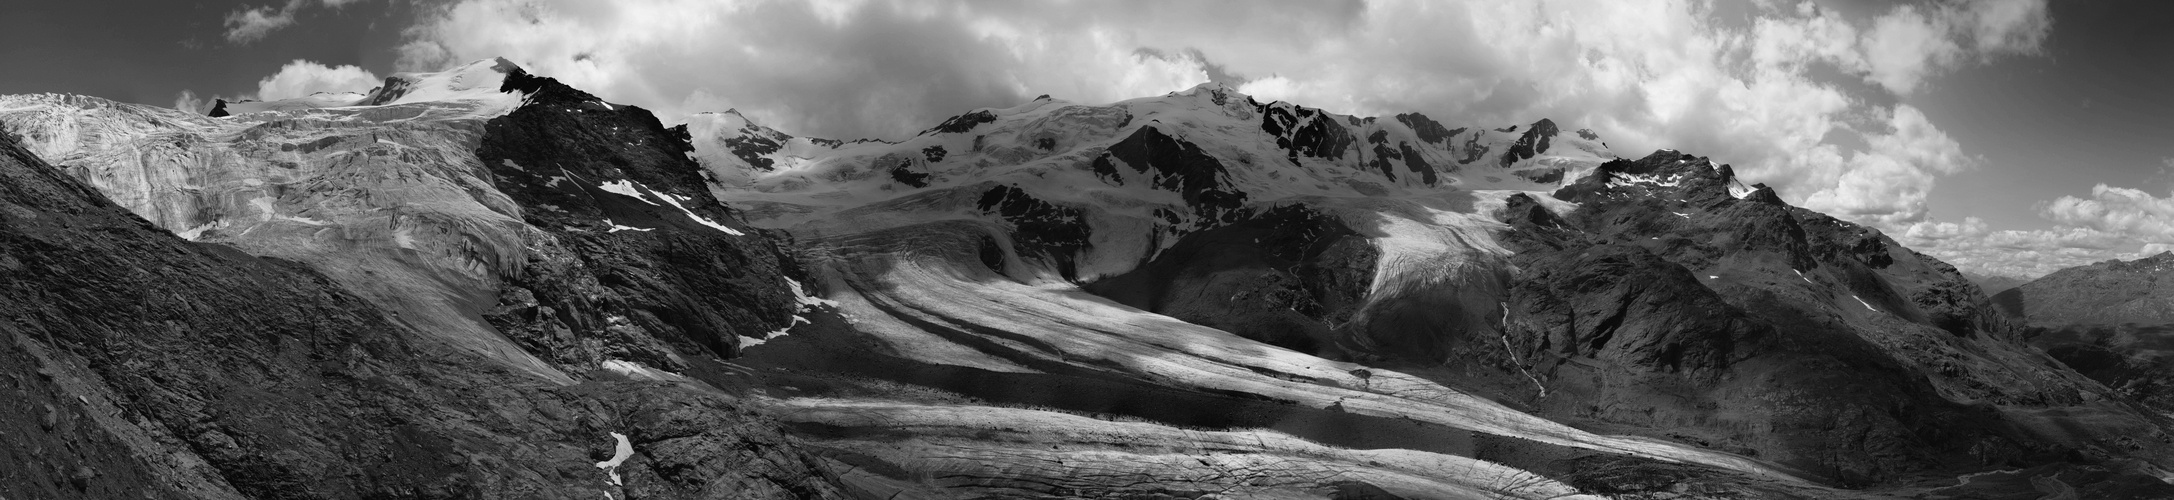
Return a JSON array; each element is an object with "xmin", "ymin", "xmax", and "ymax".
[{"xmin": 0, "ymin": 61, "xmax": 2170, "ymax": 498}]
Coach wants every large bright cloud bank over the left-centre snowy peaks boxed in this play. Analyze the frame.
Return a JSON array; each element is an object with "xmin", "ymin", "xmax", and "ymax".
[{"xmin": 400, "ymin": 0, "xmax": 1243, "ymax": 137}]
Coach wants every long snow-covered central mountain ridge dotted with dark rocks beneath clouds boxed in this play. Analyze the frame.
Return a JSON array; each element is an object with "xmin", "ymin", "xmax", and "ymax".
[{"xmin": 687, "ymin": 83, "xmax": 1613, "ymax": 232}]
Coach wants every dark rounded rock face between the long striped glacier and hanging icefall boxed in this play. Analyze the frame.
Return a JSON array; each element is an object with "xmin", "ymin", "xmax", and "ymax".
[{"xmin": 1085, "ymin": 204, "xmax": 1380, "ymax": 357}]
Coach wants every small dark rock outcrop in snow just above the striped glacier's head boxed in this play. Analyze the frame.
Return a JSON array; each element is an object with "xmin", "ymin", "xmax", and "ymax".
[{"xmin": 974, "ymin": 185, "xmax": 1091, "ymax": 278}]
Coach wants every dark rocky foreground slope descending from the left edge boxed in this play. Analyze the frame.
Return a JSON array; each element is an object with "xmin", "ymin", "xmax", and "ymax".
[{"xmin": 0, "ymin": 127, "xmax": 841, "ymax": 498}]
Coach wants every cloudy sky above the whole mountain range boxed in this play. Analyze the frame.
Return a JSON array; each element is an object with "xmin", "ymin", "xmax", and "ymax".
[{"xmin": 0, "ymin": 0, "xmax": 2174, "ymax": 278}]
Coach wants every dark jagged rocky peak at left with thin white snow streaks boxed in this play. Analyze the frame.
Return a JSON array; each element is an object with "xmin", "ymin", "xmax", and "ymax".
[{"xmin": 476, "ymin": 74, "xmax": 798, "ymax": 360}]
